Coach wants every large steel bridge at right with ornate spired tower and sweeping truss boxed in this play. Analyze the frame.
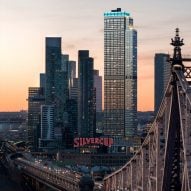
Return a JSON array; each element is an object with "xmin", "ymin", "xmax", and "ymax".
[{"xmin": 104, "ymin": 29, "xmax": 191, "ymax": 191}]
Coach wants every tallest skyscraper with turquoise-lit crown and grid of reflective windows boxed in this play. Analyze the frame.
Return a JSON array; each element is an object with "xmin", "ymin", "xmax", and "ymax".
[{"xmin": 104, "ymin": 8, "xmax": 137, "ymax": 139}]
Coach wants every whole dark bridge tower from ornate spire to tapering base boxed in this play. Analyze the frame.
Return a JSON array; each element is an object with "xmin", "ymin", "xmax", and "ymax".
[{"xmin": 162, "ymin": 28, "xmax": 184, "ymax": 191}]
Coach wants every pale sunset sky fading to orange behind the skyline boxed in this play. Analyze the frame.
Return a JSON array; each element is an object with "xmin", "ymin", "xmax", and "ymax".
[{"xmin": 0, "ymin": 0, "xmax": 191, "ymax": 111}]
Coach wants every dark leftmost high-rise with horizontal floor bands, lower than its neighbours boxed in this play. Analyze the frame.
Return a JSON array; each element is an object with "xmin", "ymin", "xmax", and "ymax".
[{"xmin": 28, "ymin": 87, "xmax": 45, "ymax": 151}]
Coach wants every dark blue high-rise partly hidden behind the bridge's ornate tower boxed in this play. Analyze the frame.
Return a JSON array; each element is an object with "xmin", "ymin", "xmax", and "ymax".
[{"xmin": 154, "ymin": 53, "xmax": 171, "ymax": 114}]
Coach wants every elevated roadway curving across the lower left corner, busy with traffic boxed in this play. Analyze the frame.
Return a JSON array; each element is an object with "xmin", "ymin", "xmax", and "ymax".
[{"xmin": 0, "ymin": 141, "xmax": 95, "ymax": 191}]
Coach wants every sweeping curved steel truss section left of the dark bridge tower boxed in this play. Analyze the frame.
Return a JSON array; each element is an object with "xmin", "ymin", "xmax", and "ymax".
[{"xmin": 104, "ymin": 75, "xmax": 172, "ymax": 191}]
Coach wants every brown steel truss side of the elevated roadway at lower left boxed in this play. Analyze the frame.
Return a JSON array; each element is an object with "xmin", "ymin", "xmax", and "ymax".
[{"xmin": 14, "ymin": 158, "xmax": 82, "ymax": 191}]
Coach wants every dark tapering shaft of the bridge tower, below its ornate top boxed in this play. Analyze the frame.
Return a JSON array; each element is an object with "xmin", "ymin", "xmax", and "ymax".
[{"xmin": 162, "ymin": 77, "xmax": 181, "ymax": 191}]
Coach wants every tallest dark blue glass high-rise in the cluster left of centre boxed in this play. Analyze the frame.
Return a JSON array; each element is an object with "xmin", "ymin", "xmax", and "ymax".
[{"xmin": 45, "ymin": 37, "xmax": 69, "ymax": 125}]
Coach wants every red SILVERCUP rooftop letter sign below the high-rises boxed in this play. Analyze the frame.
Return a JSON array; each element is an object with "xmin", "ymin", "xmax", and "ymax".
[{"xmin": 74, "ymin": 137, "xmax": 113, "ymax": 147}]
